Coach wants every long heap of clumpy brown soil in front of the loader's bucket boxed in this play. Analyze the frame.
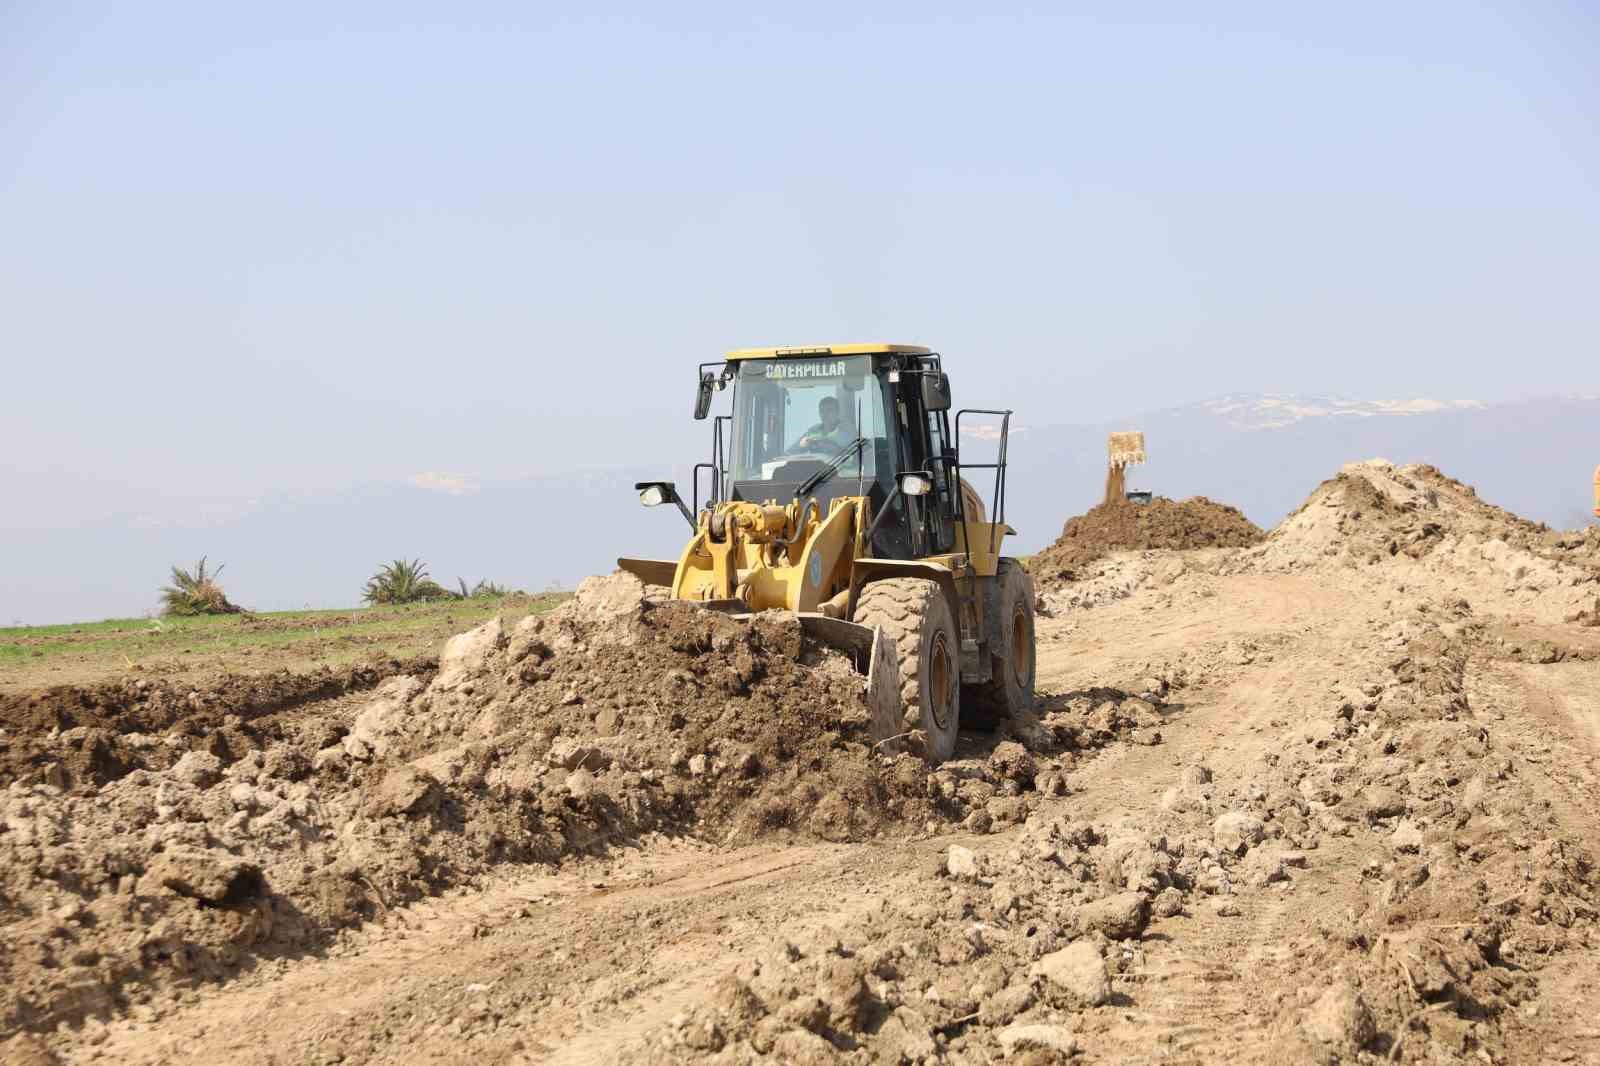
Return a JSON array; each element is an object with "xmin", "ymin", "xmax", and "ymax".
[{"xmin": 0, "ymin": 575, "xmax": 1088, "ymax": 1031}]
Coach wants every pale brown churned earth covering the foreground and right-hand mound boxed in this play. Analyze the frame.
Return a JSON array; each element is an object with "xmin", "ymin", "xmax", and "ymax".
[{"xmin": 0, "ymin": 466, "xmax": 1600, "ymax": 1064}]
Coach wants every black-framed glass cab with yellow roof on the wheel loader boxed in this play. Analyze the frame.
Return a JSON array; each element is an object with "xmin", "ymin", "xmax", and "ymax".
[{"xmin": 716, "ymin": 346, "xmax": 960, "ymax": 559}]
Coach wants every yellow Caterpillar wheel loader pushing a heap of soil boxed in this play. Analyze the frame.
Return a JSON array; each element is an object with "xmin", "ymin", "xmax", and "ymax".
[{"xmin": 618, "ymin": 344, "xmax": 1035, "ymax": 762}]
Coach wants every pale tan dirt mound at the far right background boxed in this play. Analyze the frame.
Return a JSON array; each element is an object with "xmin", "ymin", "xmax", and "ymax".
[{"xmin": 1251, "ymin": 459, "xmax": 1600, "ymax": 623}]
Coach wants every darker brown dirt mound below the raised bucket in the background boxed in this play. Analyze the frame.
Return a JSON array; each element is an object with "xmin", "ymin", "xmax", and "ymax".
[{"xmin": 1029, "ymin": 496, "xmax": 1266, "ymax": 584}]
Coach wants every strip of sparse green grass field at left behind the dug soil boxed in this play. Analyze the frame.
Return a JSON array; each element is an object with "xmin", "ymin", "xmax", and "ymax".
[{"xmin": 0, "ymin": 592, "xmax": 568, "ymax": 688}]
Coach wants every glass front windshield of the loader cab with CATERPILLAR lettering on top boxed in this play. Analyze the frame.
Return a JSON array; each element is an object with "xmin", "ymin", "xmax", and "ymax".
[{"xmin": 731, "ymin": 355, "xmax": 893, "ymax": 483}]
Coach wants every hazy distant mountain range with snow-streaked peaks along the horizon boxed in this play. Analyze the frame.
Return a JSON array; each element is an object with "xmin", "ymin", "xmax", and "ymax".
[{"xmin": 0, "ymin": 395, "xmax": 1600, "ymax": 624}]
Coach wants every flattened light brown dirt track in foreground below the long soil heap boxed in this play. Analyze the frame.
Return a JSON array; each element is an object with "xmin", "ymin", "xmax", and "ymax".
[{"xmin": 70, "ymin": 840, "xmax": 938, "ymax": 1063}]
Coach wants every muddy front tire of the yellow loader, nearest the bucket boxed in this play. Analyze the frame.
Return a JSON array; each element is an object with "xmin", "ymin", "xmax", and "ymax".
[{"xmin": 853, "ymin": 578, "xmax": 962, "ymax": 763}]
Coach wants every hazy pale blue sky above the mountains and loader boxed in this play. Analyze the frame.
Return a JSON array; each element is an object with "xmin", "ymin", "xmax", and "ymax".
[{"xmin": 0, "ymin": 0, "xmax": 1600, "ymax": 621}]
